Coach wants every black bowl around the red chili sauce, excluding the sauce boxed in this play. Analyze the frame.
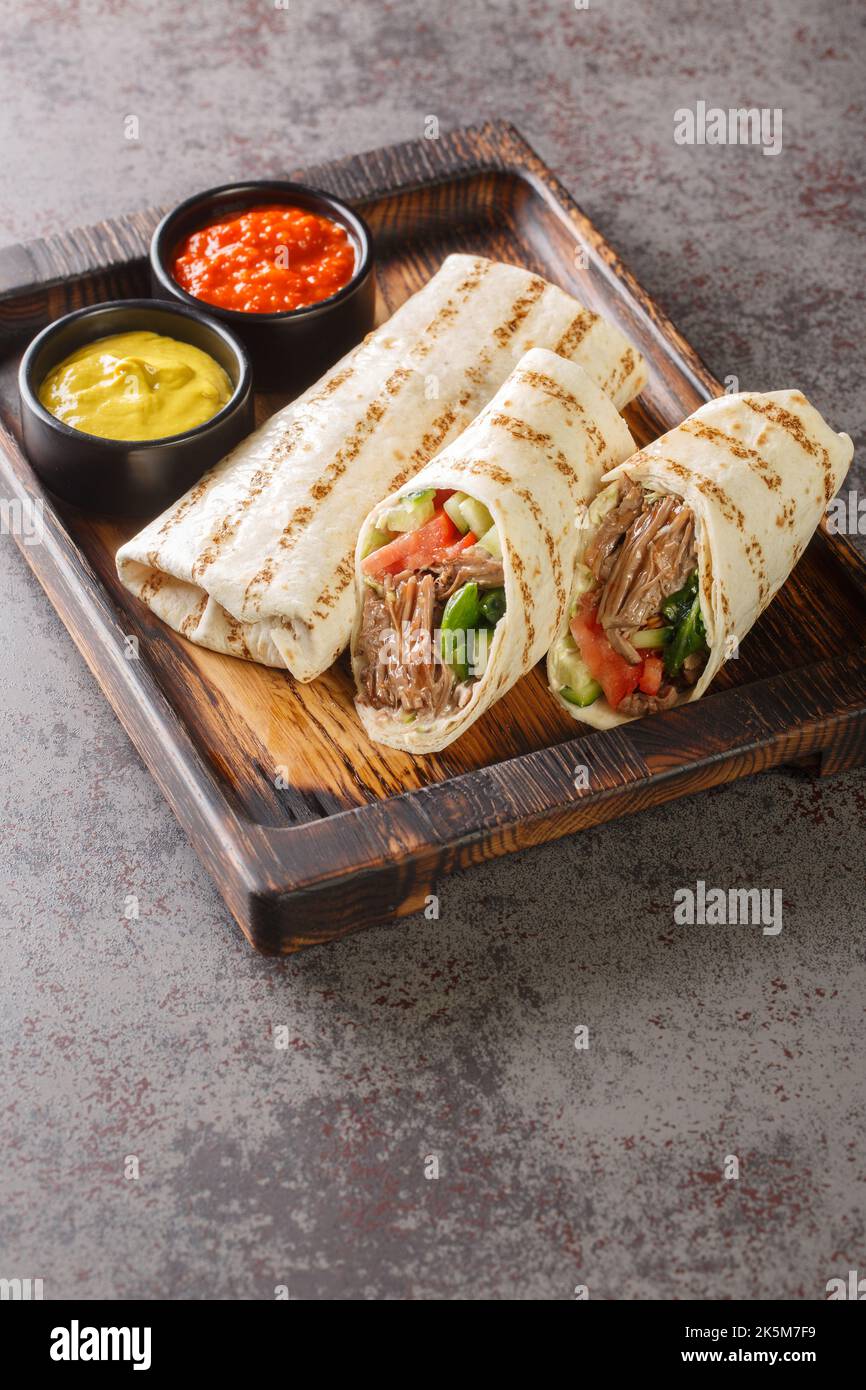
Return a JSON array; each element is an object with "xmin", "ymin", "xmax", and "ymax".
[{"xmin": 150, "ymin": 179, "xmax": 375, "ymax": 393}]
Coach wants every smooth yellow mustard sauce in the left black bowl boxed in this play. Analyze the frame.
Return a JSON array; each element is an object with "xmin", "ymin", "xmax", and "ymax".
[{"xmin": 39, "ymin": 332, "xmax": 232, "ymax": 439}]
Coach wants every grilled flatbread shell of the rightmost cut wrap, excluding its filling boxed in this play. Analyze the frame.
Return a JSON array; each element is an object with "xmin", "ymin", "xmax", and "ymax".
[{"xmin": 548, "ymin": 391, "xmax": 853, "ymax": 728}]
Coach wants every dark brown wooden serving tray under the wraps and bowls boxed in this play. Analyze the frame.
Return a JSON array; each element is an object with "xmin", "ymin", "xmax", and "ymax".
[{"xmin": 0, "ymin": 122, "xmax": 866, "ymax": 952}]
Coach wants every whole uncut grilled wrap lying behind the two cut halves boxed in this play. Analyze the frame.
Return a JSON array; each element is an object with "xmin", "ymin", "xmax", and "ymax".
[{"xmin": 117, "ymin": 256, "xmax": 646, "ymax": 681}]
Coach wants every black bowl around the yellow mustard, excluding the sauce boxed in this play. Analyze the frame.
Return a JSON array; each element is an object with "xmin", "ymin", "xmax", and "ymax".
[{"xmin": 18, "ymin": 299, "xmax": 254, "ymax": 516}]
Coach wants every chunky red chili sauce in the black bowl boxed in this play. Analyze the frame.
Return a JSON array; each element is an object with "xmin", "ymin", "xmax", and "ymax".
[{"xmin": 171, "ymin": 203, "xmax": 354, "ymax": 314}]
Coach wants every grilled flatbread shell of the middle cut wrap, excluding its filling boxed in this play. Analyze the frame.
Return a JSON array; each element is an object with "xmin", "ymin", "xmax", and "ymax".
[{"xmin": 352, "ymin": 348, "xmax": 634, "ymax": 753}]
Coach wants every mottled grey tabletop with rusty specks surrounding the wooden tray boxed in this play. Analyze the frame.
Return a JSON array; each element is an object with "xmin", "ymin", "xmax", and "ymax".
[{"xmin": 0, "ymin": 0, "xmax": 866, "ymax": 1300}]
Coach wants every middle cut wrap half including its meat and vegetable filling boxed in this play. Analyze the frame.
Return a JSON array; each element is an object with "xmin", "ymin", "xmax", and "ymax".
[{"xmin": 352, "ymin": 348, "xmax": 634, "ymax": 753}]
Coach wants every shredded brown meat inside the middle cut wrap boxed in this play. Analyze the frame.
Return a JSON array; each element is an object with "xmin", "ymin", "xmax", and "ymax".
[{"xmin": 357, "ymin": 546, "xmax": 505, "ymax": 719}]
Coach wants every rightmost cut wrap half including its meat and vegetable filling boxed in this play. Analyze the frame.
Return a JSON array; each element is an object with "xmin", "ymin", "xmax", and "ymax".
[{"xmin": 548, "ymin": 391, "xmax": 853, "ymax": 728}]
